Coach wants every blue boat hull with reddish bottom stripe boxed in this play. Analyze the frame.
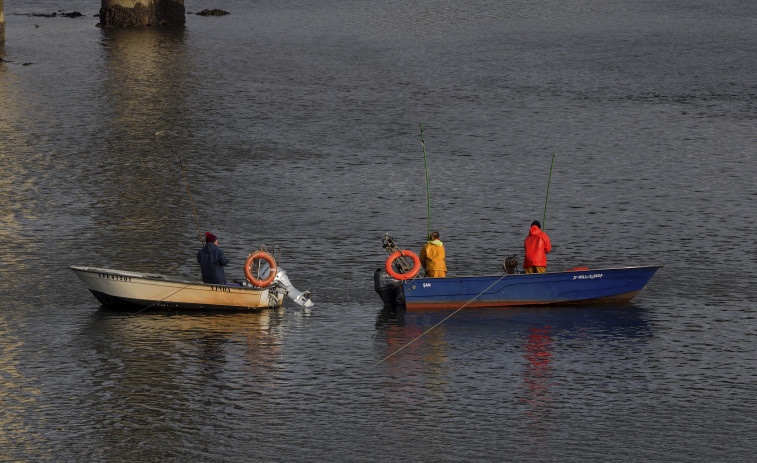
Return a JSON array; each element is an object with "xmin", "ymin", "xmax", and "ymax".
[{"xmin": 397, "ymin": 266, "xmax": 660, "ymax": 311}]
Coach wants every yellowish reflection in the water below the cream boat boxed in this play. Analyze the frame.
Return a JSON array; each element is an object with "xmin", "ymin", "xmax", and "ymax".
[{"xmin": 80, "ymin": 307, "xmax": 286, "ymax": 394}]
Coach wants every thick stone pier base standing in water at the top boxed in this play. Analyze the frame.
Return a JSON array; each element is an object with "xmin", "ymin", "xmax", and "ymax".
[{"xmin": 99, "ymin": 0, "xmax": 185, "ymax": 27}]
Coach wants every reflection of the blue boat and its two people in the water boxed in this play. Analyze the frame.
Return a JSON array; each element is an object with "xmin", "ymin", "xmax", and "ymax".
[{"xmin": 376, "ymin": 303, "xmax": 652, "ymax": 454}]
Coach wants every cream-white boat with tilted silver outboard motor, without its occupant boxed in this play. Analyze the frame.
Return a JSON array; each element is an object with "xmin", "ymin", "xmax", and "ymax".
[{"xmin": 68, "ymin": 265, "xmax": 313, "ymax": 311}]
